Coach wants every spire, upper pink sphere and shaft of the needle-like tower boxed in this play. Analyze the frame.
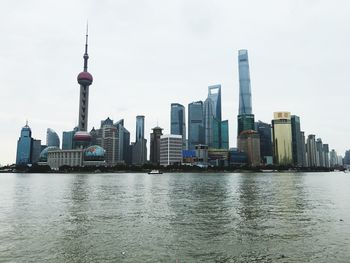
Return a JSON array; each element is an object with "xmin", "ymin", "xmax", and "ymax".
[{"xmin": 77, "ymin": 27, "xmax": 93, "ymax": 131}]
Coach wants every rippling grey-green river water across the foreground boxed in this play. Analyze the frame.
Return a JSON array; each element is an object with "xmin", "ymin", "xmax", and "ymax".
[{"xmin": 0, "ymin": 173, "xmax": 350, "ymax": 263}]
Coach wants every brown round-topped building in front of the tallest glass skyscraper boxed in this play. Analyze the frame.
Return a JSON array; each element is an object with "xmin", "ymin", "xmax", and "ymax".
[{"xmin": 237, "ymin": 130, "xmax": 261, "ymax": 166}]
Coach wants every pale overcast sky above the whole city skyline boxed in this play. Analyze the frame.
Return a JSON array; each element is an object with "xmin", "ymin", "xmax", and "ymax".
[{"xmin": 0, "ymin": 0, "xmax": 350, "ymax": 164}]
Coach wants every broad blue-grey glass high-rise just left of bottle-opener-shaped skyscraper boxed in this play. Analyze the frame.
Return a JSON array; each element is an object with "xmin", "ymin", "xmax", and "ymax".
[{"xmin": 188, "ymin": 101, "xmax": 205, "ymax": 150}]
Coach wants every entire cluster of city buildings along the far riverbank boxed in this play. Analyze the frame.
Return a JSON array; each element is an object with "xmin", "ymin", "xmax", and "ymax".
[{"xmin": 16, "ymin": 34, "xmax": 350, "ymax": 169}]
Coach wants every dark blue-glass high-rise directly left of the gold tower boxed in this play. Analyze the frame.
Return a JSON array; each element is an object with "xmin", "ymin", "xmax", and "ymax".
[{"xmin": 255, "ymin": 121, "xmax": 273, "ymax": 164}]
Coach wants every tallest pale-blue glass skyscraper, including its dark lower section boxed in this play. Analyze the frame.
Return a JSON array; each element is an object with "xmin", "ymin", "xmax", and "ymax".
[{"xmin": 237, "ymin": 49, "xmax": 254, "ymax": 136}]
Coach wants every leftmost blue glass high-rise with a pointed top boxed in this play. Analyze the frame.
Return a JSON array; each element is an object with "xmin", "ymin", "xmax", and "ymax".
[{"xmin": 16, "ymin": 122, "xmax": 33, "ymax": 165}]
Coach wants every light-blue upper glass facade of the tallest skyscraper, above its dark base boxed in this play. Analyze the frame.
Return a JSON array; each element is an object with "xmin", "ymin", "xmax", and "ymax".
[{"xmin": 238, "ymin": 50, "xmax": 253, "ymax": 115}]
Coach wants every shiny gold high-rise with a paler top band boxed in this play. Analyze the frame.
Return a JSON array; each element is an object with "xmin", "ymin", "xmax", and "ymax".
[{"xmin": 272, "ymin": 112, "xmax": 293, "ymax": 165}]
